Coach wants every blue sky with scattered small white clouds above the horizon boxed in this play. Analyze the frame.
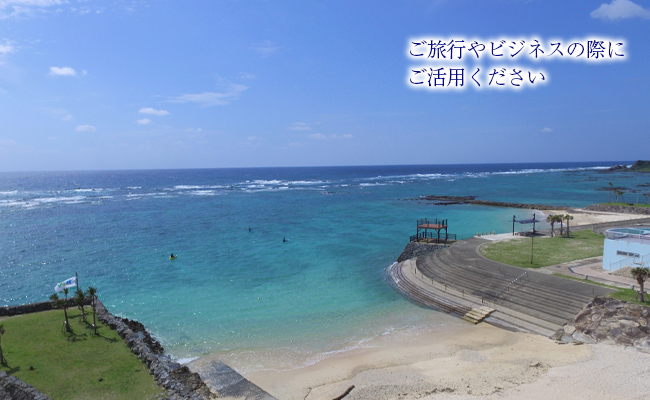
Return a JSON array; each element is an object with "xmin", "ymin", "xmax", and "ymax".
[{"xmin": 0, "ymin": 0, "xmax": 650, "ymax": 171}]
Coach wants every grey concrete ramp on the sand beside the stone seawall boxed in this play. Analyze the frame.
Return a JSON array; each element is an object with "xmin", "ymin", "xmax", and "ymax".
[{"xmin": 200, "ymin": 361, "xmax": 277, "ymax": 400}]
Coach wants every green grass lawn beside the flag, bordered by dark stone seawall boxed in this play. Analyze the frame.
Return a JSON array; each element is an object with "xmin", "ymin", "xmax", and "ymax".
[{"xmin": 0, "ymin": 307, "xmax": 163, "ymax": 400}]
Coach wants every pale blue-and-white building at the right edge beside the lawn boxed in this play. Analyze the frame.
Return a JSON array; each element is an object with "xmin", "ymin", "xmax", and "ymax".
[{"xmin": 603, "ymin": 228, "xmax": 650, "ymax": 271}]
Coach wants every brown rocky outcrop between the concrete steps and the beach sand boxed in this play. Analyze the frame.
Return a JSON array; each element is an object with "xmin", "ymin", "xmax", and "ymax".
[{"xmin": 552, "ymin": 297, "xmax": 650, "ymax": 353}]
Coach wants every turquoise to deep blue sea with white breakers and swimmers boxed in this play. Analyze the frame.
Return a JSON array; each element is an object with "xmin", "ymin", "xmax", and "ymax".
[{"xmin": 0, "ymin": 162, "xmax": 650, "ymax": 371}]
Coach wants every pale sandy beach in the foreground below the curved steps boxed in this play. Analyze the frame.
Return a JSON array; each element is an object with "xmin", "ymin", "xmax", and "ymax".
[{"xmin": 247, "ymin": 324, "xmax": 650, "ymax": 400}]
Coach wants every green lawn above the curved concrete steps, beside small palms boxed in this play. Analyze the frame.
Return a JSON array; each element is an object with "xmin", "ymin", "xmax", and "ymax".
[{"xmin": 480, "ymin": 230, "xmax": 604, "ymax": 268}]
